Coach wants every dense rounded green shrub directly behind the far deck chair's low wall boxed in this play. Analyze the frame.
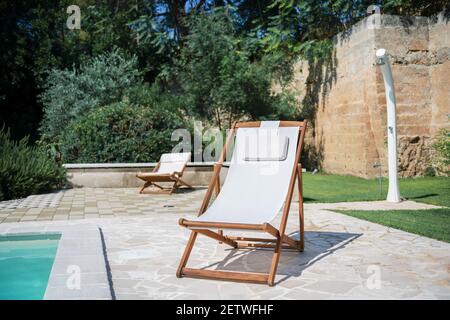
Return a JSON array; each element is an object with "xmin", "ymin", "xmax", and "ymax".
[{"xmin": 60, "ymin": 88, "xmax": 186, "ymax": 163}]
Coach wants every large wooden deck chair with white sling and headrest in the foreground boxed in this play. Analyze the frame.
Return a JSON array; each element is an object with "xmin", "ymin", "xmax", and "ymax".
[{"xmin": 176, "ymin": 121, "xmax": 307, "ymax": 286}]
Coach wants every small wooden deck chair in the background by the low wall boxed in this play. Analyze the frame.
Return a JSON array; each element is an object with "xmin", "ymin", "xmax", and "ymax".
[{"xmin": 136, "ymin": 152, "xmax": 192, "ymax": 194}]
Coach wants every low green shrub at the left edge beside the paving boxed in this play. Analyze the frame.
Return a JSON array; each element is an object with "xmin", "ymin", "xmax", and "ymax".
[{"xmin": 0, "ymin": 128, "xmax": 66, "ymax": 200}]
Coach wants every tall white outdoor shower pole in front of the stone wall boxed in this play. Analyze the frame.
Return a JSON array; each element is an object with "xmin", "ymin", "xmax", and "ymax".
[{"xmin": 376, "ymin": 49, "xmax": 400, "ymax": 202}]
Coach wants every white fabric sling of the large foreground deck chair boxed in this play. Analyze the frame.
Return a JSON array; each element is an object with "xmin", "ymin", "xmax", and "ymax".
[{"xmin": 194, "ymin": 122, "xmax": 298, "ymax": 224}]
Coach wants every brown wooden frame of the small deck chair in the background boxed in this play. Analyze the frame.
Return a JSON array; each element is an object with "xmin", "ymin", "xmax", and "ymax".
[{"xmin": 136, "ymin": 161, "xmax": 193, "ymax": 195}]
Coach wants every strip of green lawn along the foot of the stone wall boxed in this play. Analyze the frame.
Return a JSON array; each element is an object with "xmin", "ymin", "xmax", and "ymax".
[{"xmin": 303, "ymin": 173, "xmax": 450, "ymax": 207}]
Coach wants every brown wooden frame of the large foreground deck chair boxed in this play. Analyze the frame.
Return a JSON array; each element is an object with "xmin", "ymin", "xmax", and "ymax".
[{"xmin": 176, "ymin": 121, "xmax": 307, "ymax": 286}]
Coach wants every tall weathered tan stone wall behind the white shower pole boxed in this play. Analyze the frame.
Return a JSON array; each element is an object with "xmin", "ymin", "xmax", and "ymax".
[{"xmin": 284, "ymin": 15, "xmax": 450, "ymax": 177}]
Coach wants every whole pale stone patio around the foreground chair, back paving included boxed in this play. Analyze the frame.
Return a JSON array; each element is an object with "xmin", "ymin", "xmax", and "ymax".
[{"xmin": 0, "ymin": 189, "xmax": 450, "ymax": 299}]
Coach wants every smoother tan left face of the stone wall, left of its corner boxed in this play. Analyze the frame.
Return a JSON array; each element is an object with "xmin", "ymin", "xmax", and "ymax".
[{"xmin": 315, "ymin": 18, "xmax": 378, "ymax": 176}]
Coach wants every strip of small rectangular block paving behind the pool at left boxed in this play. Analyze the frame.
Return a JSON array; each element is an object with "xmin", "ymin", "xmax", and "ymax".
[{"xmin": 0, "ymin": 188, "xmax": 205, "ymax": 223}]
